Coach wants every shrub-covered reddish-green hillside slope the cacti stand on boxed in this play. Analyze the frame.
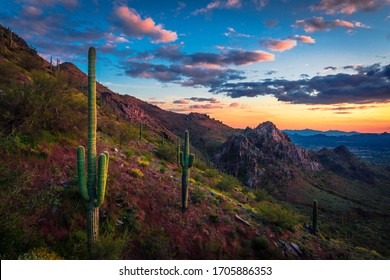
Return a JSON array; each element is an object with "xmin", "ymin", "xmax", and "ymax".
[{"xmin": 0, "ymin": 26, "xmax": 387, "ymax": 259}]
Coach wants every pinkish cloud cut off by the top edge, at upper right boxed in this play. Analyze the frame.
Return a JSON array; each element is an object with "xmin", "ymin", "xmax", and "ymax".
[{"xmin": 311, "ymin": 0, "xmax": 390, "ymax": 15}]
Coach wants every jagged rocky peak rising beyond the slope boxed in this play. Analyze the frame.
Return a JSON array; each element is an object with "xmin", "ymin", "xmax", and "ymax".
[{"xmin": 215, "ymin": 122, "xmax": 322, "ymax": 188}]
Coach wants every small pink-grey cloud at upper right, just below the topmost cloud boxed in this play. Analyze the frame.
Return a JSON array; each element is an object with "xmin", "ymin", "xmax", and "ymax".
[{"xmin": 295, "ymin": 17, "xmax": 363, "ymax": 33}]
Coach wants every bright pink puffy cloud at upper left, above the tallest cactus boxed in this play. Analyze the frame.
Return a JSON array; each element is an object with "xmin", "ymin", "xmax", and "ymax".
[{"xmin": 111, "ymin": 6, "xmax": 177, "ymax": 43}]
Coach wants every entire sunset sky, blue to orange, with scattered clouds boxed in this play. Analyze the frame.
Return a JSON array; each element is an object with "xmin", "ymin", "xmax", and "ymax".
[{"xmin": 0, "ymin": 0, "xmax": 390, "ymax": 132}]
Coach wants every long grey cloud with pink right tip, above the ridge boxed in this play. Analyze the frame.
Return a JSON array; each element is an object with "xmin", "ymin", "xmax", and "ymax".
[{"xmin": 125, "ymin": 61, "xmax": 244, "ymax": 87}]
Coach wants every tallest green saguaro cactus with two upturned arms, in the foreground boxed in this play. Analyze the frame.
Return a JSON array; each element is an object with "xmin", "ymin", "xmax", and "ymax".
[{"xmin": 77, "ymin": 47, "xmax": 109, "ymax": 255}]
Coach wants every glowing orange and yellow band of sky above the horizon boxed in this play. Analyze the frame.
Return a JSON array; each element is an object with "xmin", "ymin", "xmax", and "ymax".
[{"xmin": 162, "ymin": 97, "xmax": 390, "ymax": 133}]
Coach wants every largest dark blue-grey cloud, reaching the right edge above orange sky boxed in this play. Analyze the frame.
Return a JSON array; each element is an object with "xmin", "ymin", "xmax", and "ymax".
[{"xmin": 210, "ymin": 64, "xmax": 390, "ymax": 104}]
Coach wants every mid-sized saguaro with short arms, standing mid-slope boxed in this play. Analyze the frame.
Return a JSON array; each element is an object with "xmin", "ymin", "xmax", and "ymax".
[{"xmin": 180, "ymin": 130, "xmax": 195, "ymax": 212}]
